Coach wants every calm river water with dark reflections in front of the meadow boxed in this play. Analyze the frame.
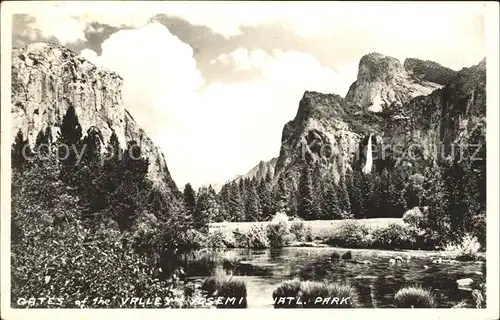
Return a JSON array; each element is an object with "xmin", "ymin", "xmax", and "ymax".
[{"xmin": 190, "ymin": 248, "xmax": 484, "ymax": 308}]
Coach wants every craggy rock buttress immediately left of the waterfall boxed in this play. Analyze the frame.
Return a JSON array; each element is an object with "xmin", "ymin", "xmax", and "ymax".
[{"xmin": 275, "ymin": 91, "xmax": 364, "ymax": 182}]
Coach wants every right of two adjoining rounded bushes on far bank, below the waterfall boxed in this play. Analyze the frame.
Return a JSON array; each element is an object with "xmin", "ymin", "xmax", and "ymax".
[{"xmin": 372, "ymin": 223, "xmax": 415, "ymax": 249}]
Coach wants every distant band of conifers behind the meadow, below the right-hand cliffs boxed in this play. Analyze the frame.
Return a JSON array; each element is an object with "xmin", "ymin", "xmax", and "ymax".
[{"xmin": 190, "ymin": 151, "xmax": 486, "ymax": 242}]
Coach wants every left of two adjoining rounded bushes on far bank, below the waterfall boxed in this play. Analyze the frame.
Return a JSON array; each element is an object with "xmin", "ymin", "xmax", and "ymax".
[{"xmin": 327, "ymin": 220, "xmax": 370, "ymax": 248}]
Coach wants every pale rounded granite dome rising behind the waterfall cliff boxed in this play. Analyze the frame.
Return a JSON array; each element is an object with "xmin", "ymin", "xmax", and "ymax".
[{"xmin": 346, "ymin": 53, "xmax": 442, "ymax": 112}]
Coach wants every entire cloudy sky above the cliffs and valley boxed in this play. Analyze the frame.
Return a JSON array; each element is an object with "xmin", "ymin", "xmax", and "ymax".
[{"xmin": 9, "ymin": 1, "xmax": 486, "ymax": 186}]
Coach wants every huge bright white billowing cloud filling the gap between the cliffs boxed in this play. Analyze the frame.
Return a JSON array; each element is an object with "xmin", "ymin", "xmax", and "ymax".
[{"xmin": 81, "ymin": 23, "xmax": 346, "ymax": 186}]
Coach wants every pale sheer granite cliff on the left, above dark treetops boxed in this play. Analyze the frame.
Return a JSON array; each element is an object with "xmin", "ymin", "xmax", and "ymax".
[{"xmin": 11, "ymin": 43, "xmax": 176, "ymax": 190}]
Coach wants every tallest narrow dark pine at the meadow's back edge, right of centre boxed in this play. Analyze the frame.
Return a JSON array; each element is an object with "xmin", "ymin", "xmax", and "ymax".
[{"xmin": 297, "ymin": 164, "xmax": 320, "ymax": 220}]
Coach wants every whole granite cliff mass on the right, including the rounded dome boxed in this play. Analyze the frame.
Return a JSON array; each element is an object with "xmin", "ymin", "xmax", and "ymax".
[{"xmin": 275, "ymin": 53, "xmax": 486, "ymax": 184}]
